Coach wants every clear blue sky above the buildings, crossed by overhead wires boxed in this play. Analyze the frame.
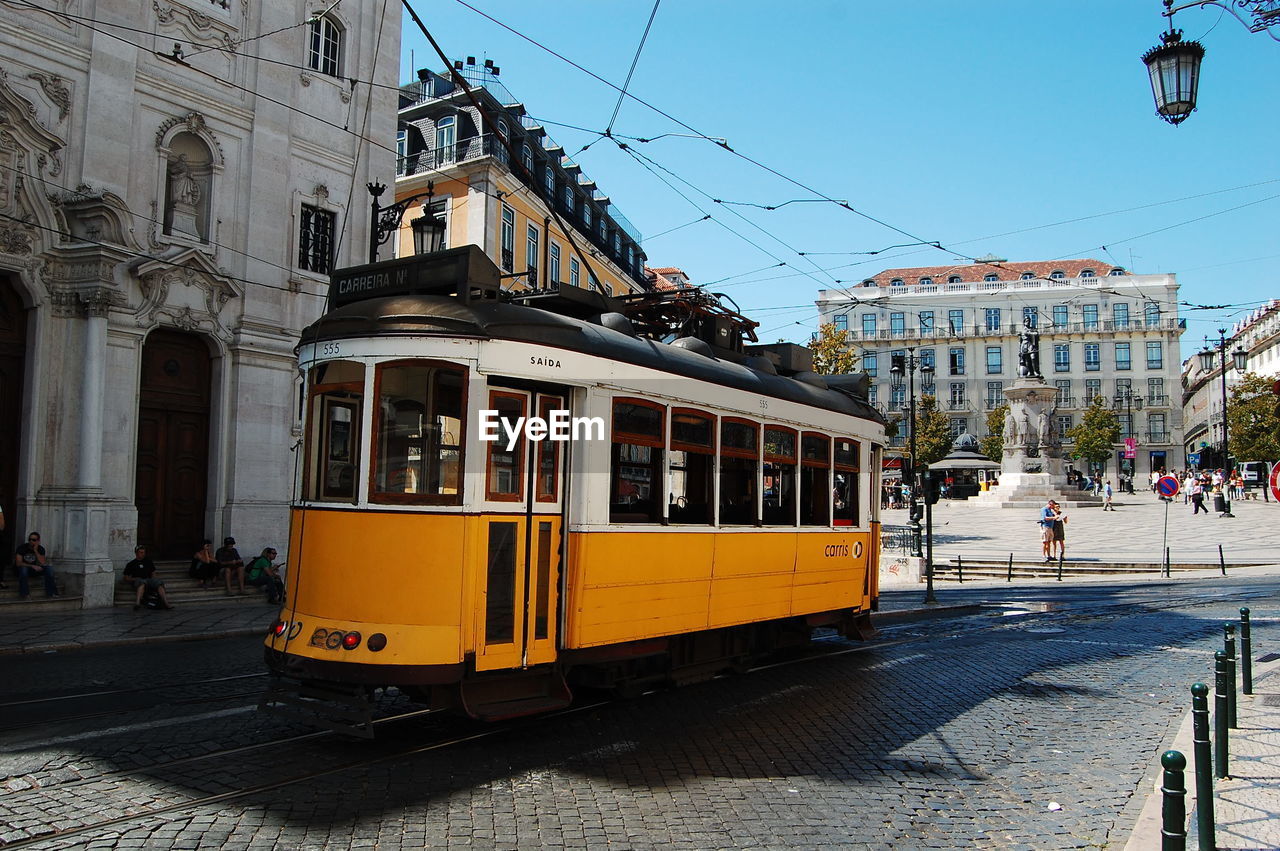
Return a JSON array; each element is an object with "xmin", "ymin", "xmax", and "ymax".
[{"xmin": 401, "ymin": 0, "xmax": 1280, "ymax": 357}]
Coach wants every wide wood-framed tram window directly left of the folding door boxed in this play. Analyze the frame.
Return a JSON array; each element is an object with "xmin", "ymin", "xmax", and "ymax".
[{"xmin": 370, "ymin": 361, "xmax": 466, "ymax": 505}]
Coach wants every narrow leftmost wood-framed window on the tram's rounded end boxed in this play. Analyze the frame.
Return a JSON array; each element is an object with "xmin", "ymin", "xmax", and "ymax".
[{"xmin": 302, "ymin": 361, "xmax": 365, "ymax": 502}]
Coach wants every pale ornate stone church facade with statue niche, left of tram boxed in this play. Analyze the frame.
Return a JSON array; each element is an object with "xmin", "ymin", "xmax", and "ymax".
[{"xmin": 0, "ymin": 0, "xmax": 401, "ymax": 607}]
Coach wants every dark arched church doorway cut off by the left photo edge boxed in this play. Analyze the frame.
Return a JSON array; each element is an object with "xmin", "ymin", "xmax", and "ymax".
[{"xmin": 0, "ymin": 275, "xmax": 27, "ymax": 560}]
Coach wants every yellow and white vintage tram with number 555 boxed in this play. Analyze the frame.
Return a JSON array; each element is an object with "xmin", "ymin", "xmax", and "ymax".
[{"xmin": 264, "ymin": 247, "xmax": 884, "ymax": 729}]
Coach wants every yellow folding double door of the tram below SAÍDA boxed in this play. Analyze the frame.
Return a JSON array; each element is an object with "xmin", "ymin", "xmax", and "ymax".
[{"xmin": 476, "ymin": 389, "xmax": 568, "ymax": 671}]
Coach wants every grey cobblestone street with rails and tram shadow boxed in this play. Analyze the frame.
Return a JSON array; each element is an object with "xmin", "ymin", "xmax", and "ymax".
[{"xmin": 0, "ymin": 577, "xmax": 1280, "ymax": 851}]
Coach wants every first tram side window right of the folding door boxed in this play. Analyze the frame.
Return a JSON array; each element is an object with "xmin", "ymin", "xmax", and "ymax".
[{"xmin": 609, "ymin": 399, "xmax": 667, "ymax": 523}]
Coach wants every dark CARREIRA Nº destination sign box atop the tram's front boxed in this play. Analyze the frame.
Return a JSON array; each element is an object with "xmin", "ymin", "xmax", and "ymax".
[{"xmin": 329, "ymin": 246, "xmax": 502, "ymax": 310}]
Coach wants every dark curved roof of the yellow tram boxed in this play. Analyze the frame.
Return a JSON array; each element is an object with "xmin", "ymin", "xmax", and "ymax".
[{"xmin": 301, "ymin": 294, "xmax": 884, "ymax": 424}]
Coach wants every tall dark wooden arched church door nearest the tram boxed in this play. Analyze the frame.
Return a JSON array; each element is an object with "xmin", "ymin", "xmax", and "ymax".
[{"xmin": 133, "ymin": 330, "xmax": 211, "ymax": 558}]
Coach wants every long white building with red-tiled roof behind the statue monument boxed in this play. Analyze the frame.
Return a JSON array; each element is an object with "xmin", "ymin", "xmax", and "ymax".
[{"xmin": 817, "ymin": 257, "xmax": 1185, "ymax": 481}]
